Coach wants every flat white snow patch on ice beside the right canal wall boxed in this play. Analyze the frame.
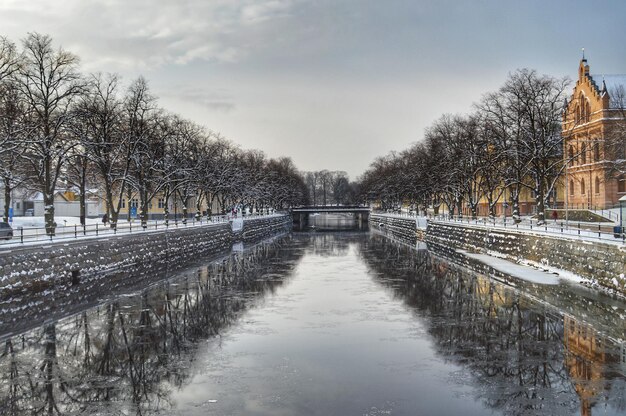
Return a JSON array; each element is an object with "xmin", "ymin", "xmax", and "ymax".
[{"xmin": 457, "ymin": 250, "xmax": 583, "ymax": 285}]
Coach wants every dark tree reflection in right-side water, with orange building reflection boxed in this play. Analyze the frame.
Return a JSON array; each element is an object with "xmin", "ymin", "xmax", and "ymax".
[{"xmin": 361, "ymin": 236, "xmax": 625, "ymax": 415}]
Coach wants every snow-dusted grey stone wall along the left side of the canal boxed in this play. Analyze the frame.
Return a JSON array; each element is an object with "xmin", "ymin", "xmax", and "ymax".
[{"xmin": 0, "ymin": 215, "xmax": 291, "ymax": 299}]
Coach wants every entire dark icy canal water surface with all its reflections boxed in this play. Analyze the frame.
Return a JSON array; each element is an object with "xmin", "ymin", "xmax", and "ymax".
[{"xmin": 0, "ymin": 233, "xmax": 626, "ymax": 416}]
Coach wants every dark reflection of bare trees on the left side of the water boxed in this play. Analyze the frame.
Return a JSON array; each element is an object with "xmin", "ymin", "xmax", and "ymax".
[{"xmin": 0, "ymin": 239, "xmax": 304, "ymax": 415}]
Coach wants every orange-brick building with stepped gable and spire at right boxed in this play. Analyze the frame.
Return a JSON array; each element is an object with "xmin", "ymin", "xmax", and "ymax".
[{"xmin": 562, "ymin": 56, "xmax": 626, "ymax": 209}]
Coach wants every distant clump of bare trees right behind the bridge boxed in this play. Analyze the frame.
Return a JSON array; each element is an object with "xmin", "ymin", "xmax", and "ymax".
[{"xmin": 304, "ymin": 170, "xmax": 358, "ymax": 205}]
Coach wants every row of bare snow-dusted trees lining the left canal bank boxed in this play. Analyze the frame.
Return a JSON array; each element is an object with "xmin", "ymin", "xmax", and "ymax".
[{"xmin": 0, "ymin": 33, "xmax": 307, "ymax": 234}]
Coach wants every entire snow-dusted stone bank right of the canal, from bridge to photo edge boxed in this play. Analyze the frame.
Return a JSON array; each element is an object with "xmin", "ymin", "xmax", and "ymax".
[{"xmin": 371, "ymin": 214, "xmax": 626, "ymax": 296}]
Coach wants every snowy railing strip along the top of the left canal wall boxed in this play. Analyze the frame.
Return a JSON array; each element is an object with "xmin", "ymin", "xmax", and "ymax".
[{"xmin": 0, "ymin": 213, "xmax": 267, "ymax": 246}]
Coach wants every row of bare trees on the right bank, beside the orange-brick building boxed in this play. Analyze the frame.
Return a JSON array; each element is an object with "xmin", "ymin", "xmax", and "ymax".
[{"xmin": 361, "ymin": 69, "xmax": 574, "ymax": 221}]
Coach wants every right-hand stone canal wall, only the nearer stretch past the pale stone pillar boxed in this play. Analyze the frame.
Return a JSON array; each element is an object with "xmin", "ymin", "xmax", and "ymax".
[{"xmin": 426, "ymin": 221, "xmax": 626, "ymax": 294}]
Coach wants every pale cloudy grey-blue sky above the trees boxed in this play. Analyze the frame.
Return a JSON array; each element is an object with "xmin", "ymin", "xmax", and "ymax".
[{"xmin": 0, "ymin": 0, "xmax": 626, "ymax": 179}]
